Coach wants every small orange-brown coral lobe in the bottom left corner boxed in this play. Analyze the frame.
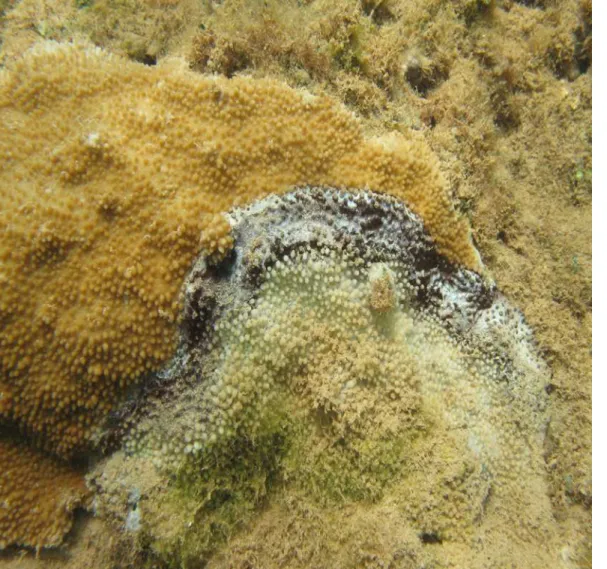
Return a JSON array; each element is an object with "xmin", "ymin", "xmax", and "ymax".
[{"xmin": 0, "ymin": 440, "xmax": 88, "ymax": 549}]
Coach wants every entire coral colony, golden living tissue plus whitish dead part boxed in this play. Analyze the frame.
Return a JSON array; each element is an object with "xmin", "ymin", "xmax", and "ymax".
[{"xmin": 0, "ymin": 43, "xmax": 549, "ymax": 560}]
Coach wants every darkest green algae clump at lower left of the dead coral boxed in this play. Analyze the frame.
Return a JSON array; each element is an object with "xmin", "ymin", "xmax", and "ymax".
[{"xmin": 152, "ymin": 404, "xmax": 293, "ymax": 567}]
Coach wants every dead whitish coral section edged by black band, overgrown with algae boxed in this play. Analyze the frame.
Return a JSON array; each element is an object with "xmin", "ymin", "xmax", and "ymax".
[{"xmin": 90, "ymin": 187, "xmax": 551, "ymax": 566}]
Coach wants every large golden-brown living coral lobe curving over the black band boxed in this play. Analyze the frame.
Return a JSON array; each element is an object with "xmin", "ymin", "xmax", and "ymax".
[{"xmin": 0, "ymin": 43, "xmax": 478, "ymax": 456}]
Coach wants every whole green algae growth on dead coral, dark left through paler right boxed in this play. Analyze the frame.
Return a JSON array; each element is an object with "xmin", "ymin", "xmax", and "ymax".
[{"xmin": 150, "ymin": 384, "xmax": 416, "ymax": 568}]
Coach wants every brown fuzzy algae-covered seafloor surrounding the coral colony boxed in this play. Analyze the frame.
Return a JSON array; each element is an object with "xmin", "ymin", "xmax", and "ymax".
[{"xmin": 0, "ymin": 0, "xmax": 592, "ymax": 569}]
